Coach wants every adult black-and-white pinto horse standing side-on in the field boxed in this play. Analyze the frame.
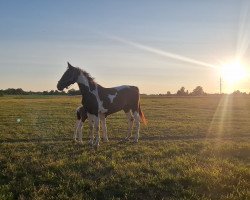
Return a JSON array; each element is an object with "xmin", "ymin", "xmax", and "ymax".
[{"xmin": 57, "ymin": 63, "xmax": 146, "ymax": 147}]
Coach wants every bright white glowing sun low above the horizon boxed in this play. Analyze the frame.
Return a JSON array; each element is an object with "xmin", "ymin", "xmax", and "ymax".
[{"xmin": 220, "ymin": 61, "xmax": 247, "ymax": 84}]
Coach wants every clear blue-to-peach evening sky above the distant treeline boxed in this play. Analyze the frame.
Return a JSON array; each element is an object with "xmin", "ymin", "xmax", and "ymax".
[{"xmin": 0, "ymin": 0, "xmax": 250, "ymax": 94}]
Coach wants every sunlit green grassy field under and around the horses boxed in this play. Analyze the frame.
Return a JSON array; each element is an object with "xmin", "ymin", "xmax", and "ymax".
[{"xmin": 0, "ymin": 96, "xmax": 250, "ymax": 200}]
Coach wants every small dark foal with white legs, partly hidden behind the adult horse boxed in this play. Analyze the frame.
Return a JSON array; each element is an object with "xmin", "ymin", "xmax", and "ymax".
[{"xmin": 74, "ymin": 106, "xmax": 108, "ymax": 144}]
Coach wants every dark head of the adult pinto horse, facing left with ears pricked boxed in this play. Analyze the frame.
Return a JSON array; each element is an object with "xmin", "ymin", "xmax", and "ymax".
[{"xmin": 57, "ymin": 63, "xmax": 79, "ymax": 91}]
